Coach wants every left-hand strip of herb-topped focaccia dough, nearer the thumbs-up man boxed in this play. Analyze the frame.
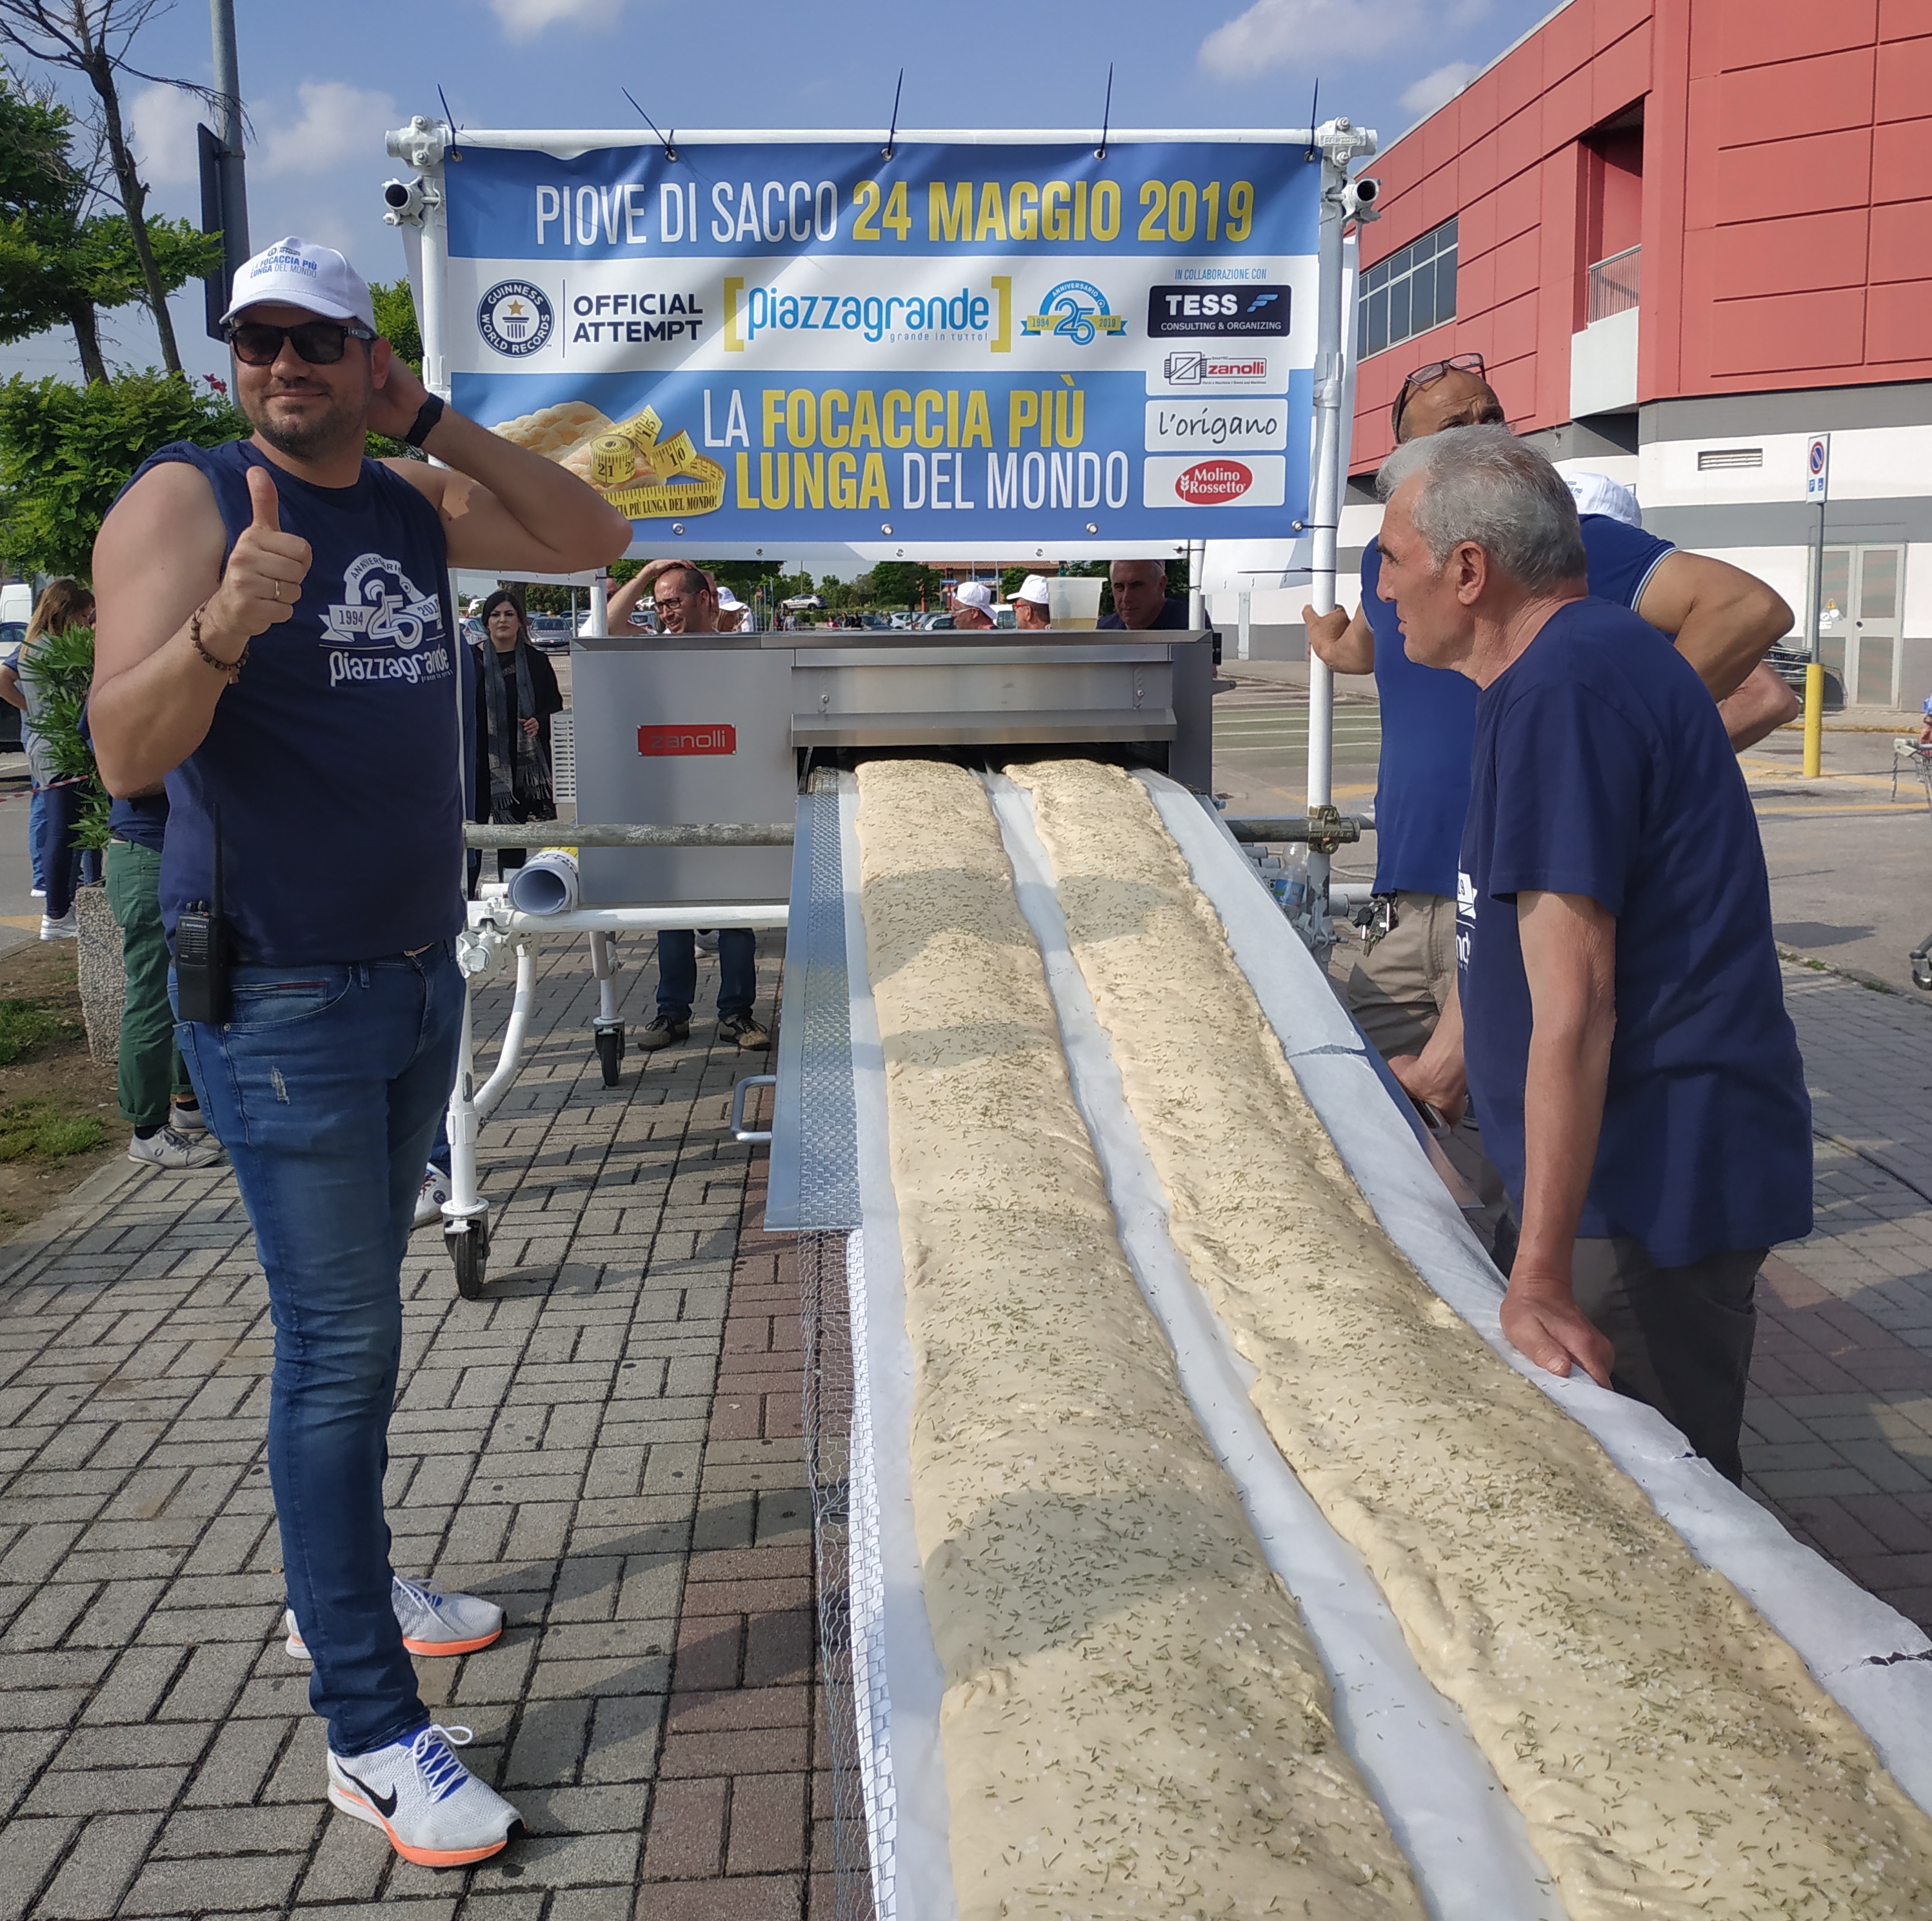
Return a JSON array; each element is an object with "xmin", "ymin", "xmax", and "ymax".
[{"xmin": 858, "ymin": 761, "xmax": 1422, "ymax": 1921}]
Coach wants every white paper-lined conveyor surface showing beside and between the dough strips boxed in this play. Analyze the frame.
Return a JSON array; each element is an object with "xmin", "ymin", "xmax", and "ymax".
[{"xmin": 767, "ymin": 775, "xmax": 1932, "ymax": 1921}]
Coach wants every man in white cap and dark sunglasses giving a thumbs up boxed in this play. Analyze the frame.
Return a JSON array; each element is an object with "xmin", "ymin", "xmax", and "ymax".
[{"xmin": 89, "ymin": 238, "xmax": 630, "ymax": 1867}]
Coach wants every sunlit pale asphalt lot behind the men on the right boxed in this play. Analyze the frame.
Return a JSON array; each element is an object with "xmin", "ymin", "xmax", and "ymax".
[{"xmin": 1213, "ymin": 682, "xmax": 1932, "ymax": 993}]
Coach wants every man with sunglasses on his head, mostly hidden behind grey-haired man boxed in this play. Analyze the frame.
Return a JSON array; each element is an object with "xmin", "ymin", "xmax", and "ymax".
[{"xmin": 1302, "ymin": 353, "xmax": 1797, "ymax": 1082}]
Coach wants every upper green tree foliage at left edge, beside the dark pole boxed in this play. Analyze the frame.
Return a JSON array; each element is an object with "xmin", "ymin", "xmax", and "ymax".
[{"xmin": 0, "ymin": 68, "xmax": 222, "ymax": 381}]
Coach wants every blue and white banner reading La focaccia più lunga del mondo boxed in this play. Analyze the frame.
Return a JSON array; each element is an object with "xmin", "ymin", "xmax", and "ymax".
[{"xmin": 443, "ymin": 134, "xmax": 1322, "ymax": 559}]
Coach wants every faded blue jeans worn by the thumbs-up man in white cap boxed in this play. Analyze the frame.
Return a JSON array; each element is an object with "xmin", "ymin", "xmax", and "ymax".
[{"xmin": 170, "ymin": 943, "xmax": 464, "ymax": 1757}]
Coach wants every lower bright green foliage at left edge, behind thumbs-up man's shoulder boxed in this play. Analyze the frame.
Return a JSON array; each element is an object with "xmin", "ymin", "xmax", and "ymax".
[{"xmin": 0, "ymin": 367, "xmax": 249, "ymax": 580}]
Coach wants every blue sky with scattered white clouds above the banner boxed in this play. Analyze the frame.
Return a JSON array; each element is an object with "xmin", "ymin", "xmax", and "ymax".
[{"xmin": 0, "ymin": 0, "xmax": 1551, "ymax": 375}]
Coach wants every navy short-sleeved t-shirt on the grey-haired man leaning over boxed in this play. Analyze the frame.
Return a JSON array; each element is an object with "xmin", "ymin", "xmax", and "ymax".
[{"xmin": 1457, "ymin": 601, "xmax": 1812, "ymax": 1268}]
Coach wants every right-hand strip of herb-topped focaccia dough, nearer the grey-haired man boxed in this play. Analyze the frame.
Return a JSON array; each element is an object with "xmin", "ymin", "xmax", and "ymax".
[{"xmin": 1010, "ymin": 761, "xmax": 1932, "ymax": 1921}]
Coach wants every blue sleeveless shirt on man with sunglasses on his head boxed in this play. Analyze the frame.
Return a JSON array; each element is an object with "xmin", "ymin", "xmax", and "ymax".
[{"xmin": 1362, "ymin": 514, "xmax": 1673, "ymax": 897}]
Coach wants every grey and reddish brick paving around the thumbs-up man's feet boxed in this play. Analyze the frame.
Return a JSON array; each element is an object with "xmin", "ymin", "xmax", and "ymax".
[{"xmin": 0, "ymin": 937, "xmax": 829, "ymax": 1921}]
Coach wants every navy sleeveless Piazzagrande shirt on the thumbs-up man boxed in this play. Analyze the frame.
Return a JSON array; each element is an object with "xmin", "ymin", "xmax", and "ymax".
[{"xmin": 130, "ymin": 441, "xmax": 464, "ymax": 966}]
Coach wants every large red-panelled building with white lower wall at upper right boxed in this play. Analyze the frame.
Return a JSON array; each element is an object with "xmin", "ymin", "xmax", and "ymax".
[{"xmin": 1343, "ymin": 0, "xmax": 1932, "ymax": 706}]
